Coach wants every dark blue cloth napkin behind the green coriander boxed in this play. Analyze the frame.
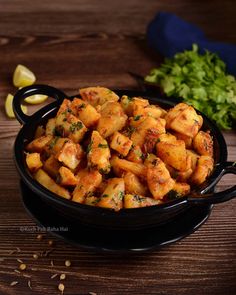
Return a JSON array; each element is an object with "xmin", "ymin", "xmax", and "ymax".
[{"xmin": 147, "ymin": 12, "xmax": 236, "ymax": 76}]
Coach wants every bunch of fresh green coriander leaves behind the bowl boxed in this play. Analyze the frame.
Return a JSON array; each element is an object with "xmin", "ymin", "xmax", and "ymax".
[{"xmin": 145, "ymin": 44, "xmax": 236, "ymax": 129}]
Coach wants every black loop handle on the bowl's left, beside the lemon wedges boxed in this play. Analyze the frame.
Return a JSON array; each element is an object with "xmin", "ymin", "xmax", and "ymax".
[{"xmin": 12, "ymin": 85, "xmax": 67, "ymax": 124}]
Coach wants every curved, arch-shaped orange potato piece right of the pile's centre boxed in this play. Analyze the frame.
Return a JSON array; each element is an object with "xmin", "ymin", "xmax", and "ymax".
[{"xmin": 131, "ymin": 117, "xmax": 165, "ymax": 147}]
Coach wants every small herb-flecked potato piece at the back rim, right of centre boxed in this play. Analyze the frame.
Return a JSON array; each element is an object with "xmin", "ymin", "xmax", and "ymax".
[{"xmin": 120, "ymin": 95, "xmax": 149, "ymax": 117}]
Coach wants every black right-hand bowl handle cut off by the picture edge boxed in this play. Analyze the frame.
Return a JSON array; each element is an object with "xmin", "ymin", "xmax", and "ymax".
[{"xmin": 187, "ymin": 162, "xmax": 236, "ymax": 204}]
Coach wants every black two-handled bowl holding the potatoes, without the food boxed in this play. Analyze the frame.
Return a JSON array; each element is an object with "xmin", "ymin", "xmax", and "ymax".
[{"xmin": 13, "ymin": 85, "xmax": 236, "ymax": 230}]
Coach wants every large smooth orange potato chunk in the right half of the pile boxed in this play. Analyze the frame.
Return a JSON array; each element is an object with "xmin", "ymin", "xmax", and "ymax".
[{"xmin": 156, "ymin": 140, "xmax": 187, "ymax": 171}]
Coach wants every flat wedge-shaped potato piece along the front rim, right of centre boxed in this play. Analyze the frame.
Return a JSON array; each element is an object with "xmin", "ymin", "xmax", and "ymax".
[{"xmin": 124, "ymin": 194, "xmax": 162, "ymax": 209}]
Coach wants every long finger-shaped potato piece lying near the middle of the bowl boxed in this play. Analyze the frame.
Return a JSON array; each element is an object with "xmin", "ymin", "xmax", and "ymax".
[{"xmin": 111, "ymin": 157, "xmax": 147, "ymax": 177}]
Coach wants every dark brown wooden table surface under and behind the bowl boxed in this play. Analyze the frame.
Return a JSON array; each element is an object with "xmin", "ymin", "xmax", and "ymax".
[{"xmin": 0, "ymin": 0, "xmax": 236, "ymax": 295}]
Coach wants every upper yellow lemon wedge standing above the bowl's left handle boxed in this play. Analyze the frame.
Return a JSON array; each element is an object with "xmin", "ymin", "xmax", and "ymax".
[{"xmin": 13, "ymin": 65, "xmax": 36, "ymax": 87}]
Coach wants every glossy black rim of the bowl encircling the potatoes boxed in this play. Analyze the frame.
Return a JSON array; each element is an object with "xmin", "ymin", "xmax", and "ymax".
[{"xmin": 14, "ymin": 89, "xmax": 228, "ymax": 216}]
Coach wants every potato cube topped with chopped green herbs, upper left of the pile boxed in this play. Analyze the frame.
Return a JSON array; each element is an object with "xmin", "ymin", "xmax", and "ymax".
[{"xmin": 56, "ymin": 112, "xmax": 87, "ymax": 143}]
